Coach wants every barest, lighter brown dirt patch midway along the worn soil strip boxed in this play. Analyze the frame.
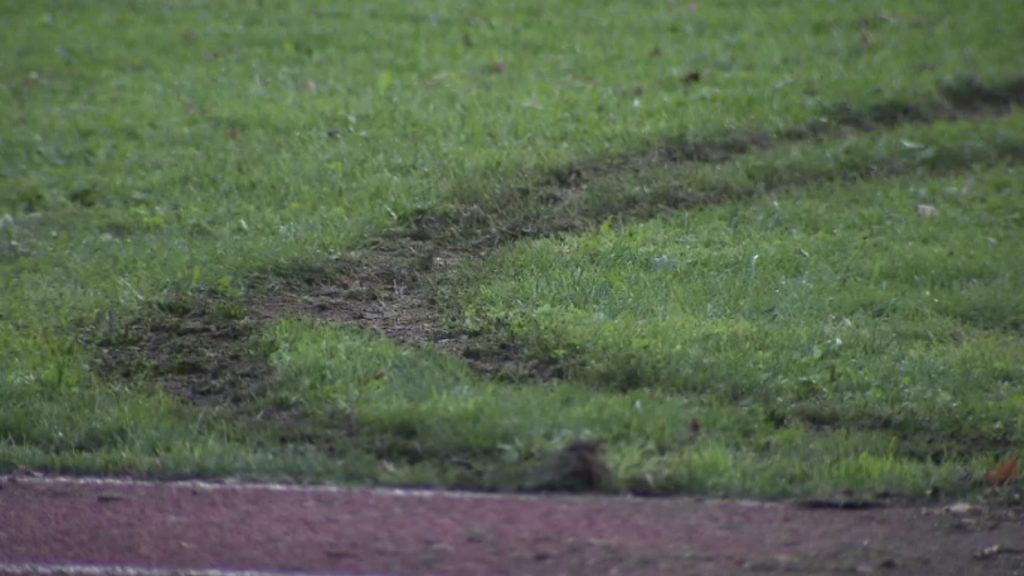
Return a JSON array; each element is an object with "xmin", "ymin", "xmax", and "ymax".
[{"xmin": 246, "ymin": 239, "xmax": 556, "ymax": 379}]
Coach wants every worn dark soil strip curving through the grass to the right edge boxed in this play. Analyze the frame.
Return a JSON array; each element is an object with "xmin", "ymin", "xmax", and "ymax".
[{"xmin": 99, "ymin": 79, "xmax": 1024, "ymax": 406}]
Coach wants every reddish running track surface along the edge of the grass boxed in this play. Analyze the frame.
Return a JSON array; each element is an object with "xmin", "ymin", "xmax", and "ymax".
[{"xmin": 0, "ymin": 478, "xmax": 1024, "ymax": 575}]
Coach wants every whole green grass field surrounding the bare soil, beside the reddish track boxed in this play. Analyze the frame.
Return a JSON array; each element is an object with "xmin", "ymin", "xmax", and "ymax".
[{"xmin": 0, "ymin": 1, "xmax": 1024, "ymax": 496}]
